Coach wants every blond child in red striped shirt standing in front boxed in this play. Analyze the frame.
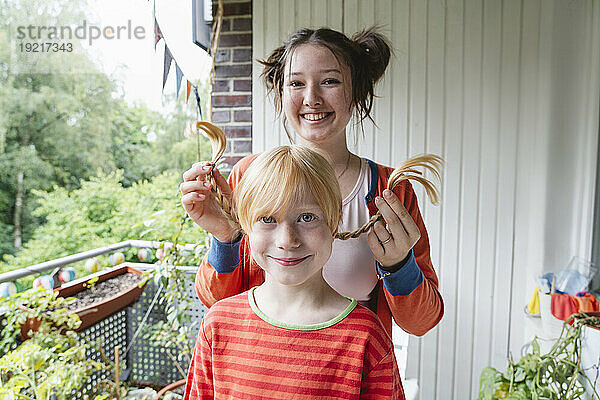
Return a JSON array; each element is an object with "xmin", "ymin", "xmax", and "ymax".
[{"xmin": 184, "ymin": 146, "xmax": 404, "ymax": 400}]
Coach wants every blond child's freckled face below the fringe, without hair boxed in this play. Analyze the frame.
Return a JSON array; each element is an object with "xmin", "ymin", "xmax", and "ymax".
[{"xmin": 248, "ymin": 196, "xmax": 333, "ymax": 286}]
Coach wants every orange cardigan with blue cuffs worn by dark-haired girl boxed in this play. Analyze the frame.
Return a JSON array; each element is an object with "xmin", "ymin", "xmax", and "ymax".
[{"xmin": 195, "ymin": 154, "xmax": 444, "ymax": 336}]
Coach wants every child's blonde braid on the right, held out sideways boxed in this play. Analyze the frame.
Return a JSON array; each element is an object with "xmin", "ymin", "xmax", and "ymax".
[{"xmin": 335, "ymin": 154, "xmax": 444, "ymax": 240}]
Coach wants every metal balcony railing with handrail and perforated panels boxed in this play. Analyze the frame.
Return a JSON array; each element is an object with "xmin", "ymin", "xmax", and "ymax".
[{"xmin": 0, "ymin": 240, "xmax": 207, "ymax": 399}]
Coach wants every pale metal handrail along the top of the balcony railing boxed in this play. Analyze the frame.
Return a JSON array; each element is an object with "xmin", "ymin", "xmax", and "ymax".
[{"xmin": 0, "ymin": 240, "xmax": 196, "ymax": 283}]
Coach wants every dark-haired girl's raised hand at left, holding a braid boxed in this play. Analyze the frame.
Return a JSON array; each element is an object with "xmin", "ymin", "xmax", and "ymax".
[{"xmin": 179, "ymin": 161, "xmax": 238, "ymax": 243}]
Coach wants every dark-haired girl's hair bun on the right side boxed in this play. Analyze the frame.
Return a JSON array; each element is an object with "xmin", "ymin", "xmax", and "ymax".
[{"xmin": 352, "ymin": 27, "xmax": 391, "ymax": 83}]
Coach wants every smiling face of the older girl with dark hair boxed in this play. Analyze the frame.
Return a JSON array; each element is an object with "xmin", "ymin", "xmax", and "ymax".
[{"xmin": 282, "ymin": 44, "xmax": 352, "ymax": 145}]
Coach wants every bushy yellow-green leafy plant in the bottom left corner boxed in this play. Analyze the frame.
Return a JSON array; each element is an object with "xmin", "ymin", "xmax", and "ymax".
[{"xmin": 0, "ymin": 289, "xmax": 113, "ymax": 400}]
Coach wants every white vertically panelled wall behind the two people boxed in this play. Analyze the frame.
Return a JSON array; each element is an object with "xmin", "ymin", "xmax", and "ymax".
[{"xmin": 253, "ymin": 0, "xmax": 600, "ymax": 400}]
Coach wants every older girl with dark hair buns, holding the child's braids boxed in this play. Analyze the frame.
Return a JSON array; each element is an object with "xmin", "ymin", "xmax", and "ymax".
[{"xmin": 181, "ymin": 28, "xmax": 443, "ymax": 335}]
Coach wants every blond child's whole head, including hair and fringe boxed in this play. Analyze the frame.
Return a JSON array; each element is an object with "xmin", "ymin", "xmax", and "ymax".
[{"xmin": 234, "ymin": 146, "xmax": 342, "ymax": 288}]
